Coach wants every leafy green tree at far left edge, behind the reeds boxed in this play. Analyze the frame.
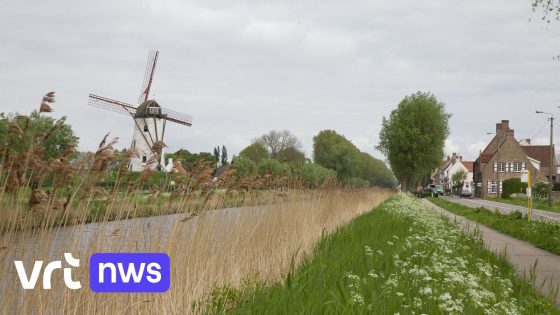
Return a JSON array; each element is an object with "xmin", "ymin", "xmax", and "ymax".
[{"xmin": 0, "ymin": 111, "xmax": 79, "ymax": 160}]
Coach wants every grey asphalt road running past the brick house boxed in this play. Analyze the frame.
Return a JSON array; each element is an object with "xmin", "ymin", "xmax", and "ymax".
[{"xmin": 440, "ymin": 196, "xmax": 560, "ymax": 222}]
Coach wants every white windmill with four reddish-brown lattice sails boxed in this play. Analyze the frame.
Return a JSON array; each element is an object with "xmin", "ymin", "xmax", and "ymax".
[{"xmin": 88, "ymin": 50, "xmax": 192, "ymax": 171}]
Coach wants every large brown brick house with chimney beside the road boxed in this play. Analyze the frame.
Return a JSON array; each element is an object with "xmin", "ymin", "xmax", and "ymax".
[{"xmin": 474, "ymin": 120, "xmax": 556, "ymax": 198}]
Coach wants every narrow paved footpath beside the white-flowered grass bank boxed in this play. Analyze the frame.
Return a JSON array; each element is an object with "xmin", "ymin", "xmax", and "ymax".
[{"xmin": 424, "ymin": 199, "xmax": 560, "ymax": 307}]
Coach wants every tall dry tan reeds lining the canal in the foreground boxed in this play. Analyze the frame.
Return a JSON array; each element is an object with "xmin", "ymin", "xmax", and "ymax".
[{"xmin": 0, "ymin": 189, "xmax": 394, "ymax": 314}]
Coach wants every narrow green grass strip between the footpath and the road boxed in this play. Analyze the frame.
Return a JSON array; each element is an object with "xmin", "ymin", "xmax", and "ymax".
[{"xmin": 428, "ymin": 198, "xmax": 560, "ymax": 254}]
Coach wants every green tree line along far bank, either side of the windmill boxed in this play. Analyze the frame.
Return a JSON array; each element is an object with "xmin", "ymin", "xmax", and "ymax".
[{"xmin": 0, "ymin": 96, "xmax": 402, "ymax": 191}]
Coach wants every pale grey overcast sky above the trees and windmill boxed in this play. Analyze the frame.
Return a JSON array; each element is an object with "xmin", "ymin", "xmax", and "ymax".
[{"xmin": 0, "ymin": 0, "xmax": 560, "ymax": 163}]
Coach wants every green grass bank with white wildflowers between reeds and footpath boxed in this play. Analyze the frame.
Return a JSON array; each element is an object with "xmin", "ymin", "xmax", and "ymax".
[{"xmin": 194, "ymin": 195, "xmax": 558, "ymax": 314}]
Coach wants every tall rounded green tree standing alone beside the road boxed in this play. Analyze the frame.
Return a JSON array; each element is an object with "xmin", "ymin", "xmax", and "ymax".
[{"xmin": 376, "ymin": 92, "xmax": 451, "ymax": 189}]
